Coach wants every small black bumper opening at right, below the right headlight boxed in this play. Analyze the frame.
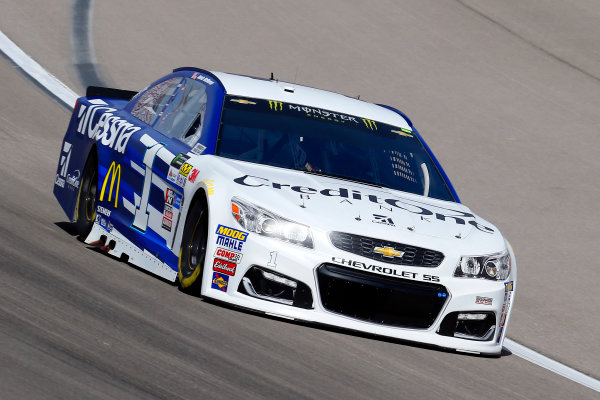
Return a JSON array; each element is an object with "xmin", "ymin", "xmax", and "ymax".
[{"xmin": 438, "ymin": 311, "xmax": 496, "ymax": 341}]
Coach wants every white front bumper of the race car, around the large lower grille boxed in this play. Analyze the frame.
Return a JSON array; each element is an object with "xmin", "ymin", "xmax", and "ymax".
[{"xmin": 202, "ymin": 235, "xmax": 516, "ymax": 355}]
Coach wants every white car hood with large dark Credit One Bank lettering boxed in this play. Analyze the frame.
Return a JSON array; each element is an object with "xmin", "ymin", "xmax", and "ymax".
[{"xmin": 204, "ymin": 157, "xmax": 504, "ymax": 251}]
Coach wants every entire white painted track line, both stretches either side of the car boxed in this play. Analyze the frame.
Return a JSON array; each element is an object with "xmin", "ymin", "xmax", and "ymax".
[{"xmin": 0, "ymin": 27, "xmax": 600, "ymax": 392}]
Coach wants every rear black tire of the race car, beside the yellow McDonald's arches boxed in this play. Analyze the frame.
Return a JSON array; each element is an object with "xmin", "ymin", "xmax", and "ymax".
[{"xmin": 75, "ymin": 155, "xmax": 98, "ymax": 239}]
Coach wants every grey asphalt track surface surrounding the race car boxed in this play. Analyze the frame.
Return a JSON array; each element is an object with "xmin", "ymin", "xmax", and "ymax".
[{"xmin": 0, "ymin": 0, "xmax": 600, "ymax": 399}]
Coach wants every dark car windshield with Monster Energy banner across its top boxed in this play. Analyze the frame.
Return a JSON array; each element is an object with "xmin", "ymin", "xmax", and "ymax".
[{"xmin": 216, "ymin": 95, "xmax": 454, "ymax": 201}]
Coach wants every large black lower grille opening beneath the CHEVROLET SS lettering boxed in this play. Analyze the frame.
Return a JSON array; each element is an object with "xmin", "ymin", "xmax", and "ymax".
[{"xmin": 317, "ymin": 264, "xmax": 449, "ymax": 329}]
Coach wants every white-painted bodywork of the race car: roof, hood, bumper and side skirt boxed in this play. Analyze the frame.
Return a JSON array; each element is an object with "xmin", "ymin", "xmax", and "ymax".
[{"xmin": 74, "ymin": 72, "xmax": 517, "ymax": 354}]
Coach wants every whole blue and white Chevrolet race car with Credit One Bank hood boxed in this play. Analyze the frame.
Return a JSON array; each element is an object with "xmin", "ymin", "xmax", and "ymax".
[{"xmin": 54, "ymin": 68, "xmax": 517, "ymax": 355}]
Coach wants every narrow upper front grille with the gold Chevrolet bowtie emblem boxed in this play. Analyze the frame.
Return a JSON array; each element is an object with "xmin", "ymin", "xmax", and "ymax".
[{"xmin": 329, "ymin": 232, "xmax": 444, "ymax": 268}]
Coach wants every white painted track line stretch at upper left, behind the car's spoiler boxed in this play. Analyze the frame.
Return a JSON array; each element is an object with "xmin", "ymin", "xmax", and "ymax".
[{"xmin": 0, "ymin": 30, "xmax": 79, "ymax": 107}]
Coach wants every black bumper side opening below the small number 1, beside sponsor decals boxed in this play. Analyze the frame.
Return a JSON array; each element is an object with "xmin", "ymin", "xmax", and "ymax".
[{"xmin": 238, "ymin": 266, "xmax": 313, "ymax": 309}]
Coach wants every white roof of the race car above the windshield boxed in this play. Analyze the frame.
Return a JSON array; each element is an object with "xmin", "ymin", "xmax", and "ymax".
[{"xmin": 211, "ymin": 71, "xmax": 412, "ymax": 130}]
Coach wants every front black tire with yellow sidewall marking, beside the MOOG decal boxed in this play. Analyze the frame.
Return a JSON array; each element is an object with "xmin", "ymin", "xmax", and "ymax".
[{"xmin": 177, "ymin": 196, "xmax": 208, "ymax": 294}]
